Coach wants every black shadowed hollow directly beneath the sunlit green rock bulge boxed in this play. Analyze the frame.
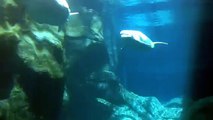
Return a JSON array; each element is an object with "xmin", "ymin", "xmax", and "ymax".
[{"xmin": 18, "ymin": 62, "xmax": 64, "ymax": 120}]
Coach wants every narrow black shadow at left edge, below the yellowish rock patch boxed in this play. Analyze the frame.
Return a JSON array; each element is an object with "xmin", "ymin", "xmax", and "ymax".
[{"xmin": 0, "ymin": 35, "xmax": 18, "ymax": 100}]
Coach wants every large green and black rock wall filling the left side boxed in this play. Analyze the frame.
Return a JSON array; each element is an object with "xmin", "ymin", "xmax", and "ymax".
[{"xmin": 0, "ymin": 0, "xmax": 64, "ymax": 120}]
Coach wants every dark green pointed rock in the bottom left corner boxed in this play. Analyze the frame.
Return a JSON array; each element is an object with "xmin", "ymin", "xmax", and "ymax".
[{"xmin": 0, "ymin": 84, "xmax": 35, "ymax": 120}]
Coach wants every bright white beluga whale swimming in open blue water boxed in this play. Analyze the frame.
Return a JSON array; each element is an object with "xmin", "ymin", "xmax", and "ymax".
[{"xmin": 120, "ymin": 30, "xmax": 168, "ymax": 48}]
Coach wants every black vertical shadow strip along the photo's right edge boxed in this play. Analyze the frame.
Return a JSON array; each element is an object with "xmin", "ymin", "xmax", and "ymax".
[{"xmin": 183, "ymin": 0, "xmax": 213, "ymax": 120}]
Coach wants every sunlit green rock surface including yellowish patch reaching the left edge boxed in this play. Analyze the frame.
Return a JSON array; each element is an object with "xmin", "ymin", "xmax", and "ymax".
[{"xmin": 0, "ymin": 22, "xmax": 63, "ymax": 78}]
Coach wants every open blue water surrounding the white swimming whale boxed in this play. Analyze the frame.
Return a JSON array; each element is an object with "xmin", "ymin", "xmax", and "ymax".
[{"xmin": 100, "ymin": 0, "xmax": 199, "ymax": 101}]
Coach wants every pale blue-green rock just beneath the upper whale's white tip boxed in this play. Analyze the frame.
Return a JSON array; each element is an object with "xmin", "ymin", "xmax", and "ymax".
[{"xmin": 64, "ymin": 7, "xmax": 103, "ymax": 40}]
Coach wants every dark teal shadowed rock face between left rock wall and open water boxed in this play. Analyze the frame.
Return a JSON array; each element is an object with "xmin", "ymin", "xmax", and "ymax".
[{"xmin": 62, "ymin": 43, "xmax": 124, "ymax": 120}]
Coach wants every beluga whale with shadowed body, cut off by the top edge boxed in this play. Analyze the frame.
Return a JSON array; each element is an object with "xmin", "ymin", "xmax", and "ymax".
[{"xmin": 22, "ymin": 0, "xmax": 79, "ymax": 27}]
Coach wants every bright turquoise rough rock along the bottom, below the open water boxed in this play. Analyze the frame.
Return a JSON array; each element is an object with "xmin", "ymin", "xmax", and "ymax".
[{"xmin": 98, "ymin": 88, "xmax": 182, "ymax": 120}]
